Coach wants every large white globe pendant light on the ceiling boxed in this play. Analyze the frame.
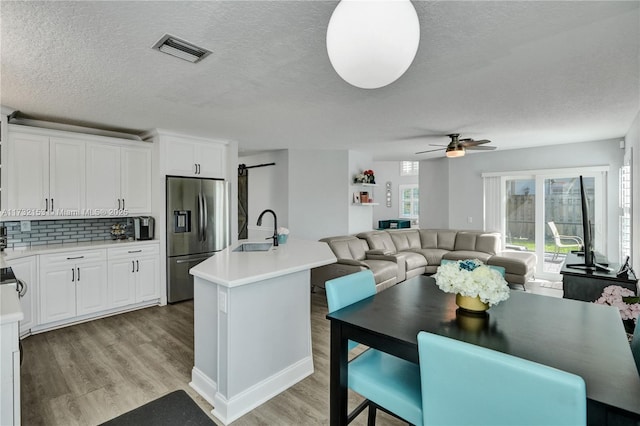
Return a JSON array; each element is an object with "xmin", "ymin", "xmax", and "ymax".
[{"xmin": 327, "ymin": 0, "xmax": 420, "ymax": 89}]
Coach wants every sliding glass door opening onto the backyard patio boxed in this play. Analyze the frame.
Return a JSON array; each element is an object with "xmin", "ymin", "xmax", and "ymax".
[{"xmin": 500, "ymin": 170, "xmax": 607, "ymax": 280}]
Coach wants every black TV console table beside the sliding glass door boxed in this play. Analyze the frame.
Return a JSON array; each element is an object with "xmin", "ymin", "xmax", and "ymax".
[{"xmin": 560, "ymin": 253, "xmax": 638, "ymax": 302}]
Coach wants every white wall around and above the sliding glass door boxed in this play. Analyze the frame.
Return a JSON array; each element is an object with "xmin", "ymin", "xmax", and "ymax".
[{"xmin": 420, "ymin": 139, "xmax": 624, "ymax": 262}]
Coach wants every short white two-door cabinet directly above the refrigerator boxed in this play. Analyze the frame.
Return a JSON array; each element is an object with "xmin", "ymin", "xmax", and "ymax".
[{"xmin": 162, "ymin": 136, "xmax": 227, "ymax": 179}]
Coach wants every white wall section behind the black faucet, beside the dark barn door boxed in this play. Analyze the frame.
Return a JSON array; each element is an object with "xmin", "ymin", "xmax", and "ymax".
[{"xmin": 240, "ymin": 150, "xmax": 289, "ymax": 240}]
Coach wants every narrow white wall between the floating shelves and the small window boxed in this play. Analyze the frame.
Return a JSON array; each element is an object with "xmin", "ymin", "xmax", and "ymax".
[{"xmin": 372, "ymin": 161, "xmax": 419, "ymax": 228}]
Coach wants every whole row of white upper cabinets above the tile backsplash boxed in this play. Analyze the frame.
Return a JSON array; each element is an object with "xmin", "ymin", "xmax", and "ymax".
[{"xmin": 6, "ymin": 125, "xmax": 152, "ymax": 219}]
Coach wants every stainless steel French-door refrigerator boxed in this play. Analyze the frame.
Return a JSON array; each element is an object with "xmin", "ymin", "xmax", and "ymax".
[{"xmin": 167, "ymin": 176, "xmax": 230, "ymax": 303}]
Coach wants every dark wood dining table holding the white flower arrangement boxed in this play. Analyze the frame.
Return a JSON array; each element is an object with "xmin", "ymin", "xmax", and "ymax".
[{"xmin": 327, "ymin": 275, "xmax": 640, "ymax": 426}]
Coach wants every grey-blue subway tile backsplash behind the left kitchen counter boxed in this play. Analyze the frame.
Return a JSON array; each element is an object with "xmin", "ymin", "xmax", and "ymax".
[{"xmin": 3, "ymin": 218, "xmax": 132, "ymax": 248}]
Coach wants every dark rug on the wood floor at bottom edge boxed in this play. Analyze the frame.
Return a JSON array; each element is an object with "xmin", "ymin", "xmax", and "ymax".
[{"xmin": 102, "ymin": 390, "xmax": 216, "ymax": 426}]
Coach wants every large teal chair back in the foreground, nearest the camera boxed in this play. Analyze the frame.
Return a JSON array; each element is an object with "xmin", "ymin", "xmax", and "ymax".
[{"xmin": 418, "ymin": 331, "xmax": 587, "ymax": 426}]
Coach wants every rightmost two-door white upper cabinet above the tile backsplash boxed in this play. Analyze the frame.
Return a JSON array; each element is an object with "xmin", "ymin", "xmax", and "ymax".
[{"xmin": 87, "ymin": 142, "xmax": 152, "ymax": 214}]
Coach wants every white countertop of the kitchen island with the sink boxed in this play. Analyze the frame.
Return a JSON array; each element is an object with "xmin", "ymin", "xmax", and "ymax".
[{"xmin": 189, "ymin": 238, "xmax": 337, "ymax": 287}]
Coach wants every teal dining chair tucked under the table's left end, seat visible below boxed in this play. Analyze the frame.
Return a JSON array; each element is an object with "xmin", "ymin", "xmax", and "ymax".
[{"xmin": 325, "ymin": 269, "xmax": 422, "ymax": 425}]
